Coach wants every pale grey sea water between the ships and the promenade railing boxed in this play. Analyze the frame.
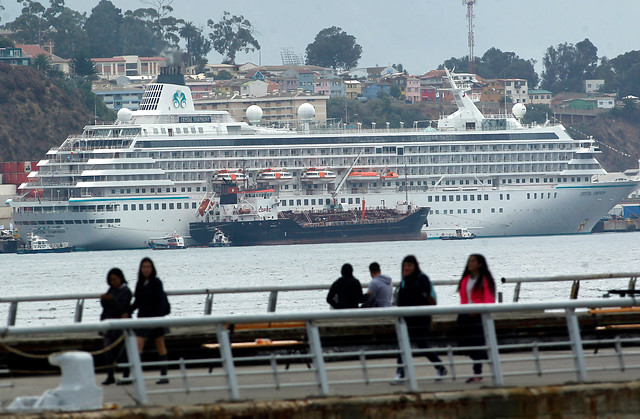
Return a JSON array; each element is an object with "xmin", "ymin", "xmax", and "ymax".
[{"xmin": 0, "ymin": 232, "xmax": 640, "ymax": 325}]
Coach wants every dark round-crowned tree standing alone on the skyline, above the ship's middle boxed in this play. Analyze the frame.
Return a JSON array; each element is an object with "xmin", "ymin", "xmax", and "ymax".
[{"xmin": 306, "ymin": 26, "xmax": 362, "ymax": 69}]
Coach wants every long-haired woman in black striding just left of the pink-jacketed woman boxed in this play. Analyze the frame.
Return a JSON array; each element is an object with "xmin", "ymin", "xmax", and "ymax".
[{"xmin": 396, "ymin": 255, "xmax": 448, "ymax": 382}]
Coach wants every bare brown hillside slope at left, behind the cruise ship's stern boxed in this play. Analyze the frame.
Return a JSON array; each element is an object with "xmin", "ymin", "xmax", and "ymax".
[{"xmin": 0, "ymin": 64, "xmax": 94, "ymax": 161}]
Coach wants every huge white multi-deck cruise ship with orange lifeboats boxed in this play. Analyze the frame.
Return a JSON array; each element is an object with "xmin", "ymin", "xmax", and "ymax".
[{"xmin": 7, "ymin": 68, "xmax": 638, "ymax": 249}]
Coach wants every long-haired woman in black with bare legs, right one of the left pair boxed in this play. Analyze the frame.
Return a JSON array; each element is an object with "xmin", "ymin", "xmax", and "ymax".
[{"xmin": 130, "ymin": 257, "xmax": 169, "ymax": 384}]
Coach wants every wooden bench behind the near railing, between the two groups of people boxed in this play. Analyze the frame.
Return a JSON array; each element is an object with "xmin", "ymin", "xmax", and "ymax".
[{"xmin": 202, "ymin": 322, "xmax": 311, "ymax": 372}]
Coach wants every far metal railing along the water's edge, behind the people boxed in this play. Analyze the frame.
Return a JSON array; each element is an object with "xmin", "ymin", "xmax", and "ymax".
[{"xmin": 0, "ymin": 272, "xmax": 640, "ymax": 326}]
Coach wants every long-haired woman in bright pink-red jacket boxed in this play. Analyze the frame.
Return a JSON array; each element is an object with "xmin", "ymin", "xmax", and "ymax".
[{"xmin": 457, "ymin": 254, "xmax": 496, "ymax": 383}]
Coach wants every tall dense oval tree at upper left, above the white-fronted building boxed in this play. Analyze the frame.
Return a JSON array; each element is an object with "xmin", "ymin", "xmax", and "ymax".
[{"xmin": 84, "ymin": 0, "xmax": 123, "ymax": 58}]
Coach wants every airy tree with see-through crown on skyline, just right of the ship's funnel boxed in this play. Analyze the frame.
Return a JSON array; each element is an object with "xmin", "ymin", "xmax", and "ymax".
[{"xmin": 207, "ymin": 11, "xmax": 260, "ymax": 64}]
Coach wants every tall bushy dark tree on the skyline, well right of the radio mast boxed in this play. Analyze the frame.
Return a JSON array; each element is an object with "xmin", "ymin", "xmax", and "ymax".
[{"xmin": 540, "ymin": 39, "xmax": 598, "ymax": 93}]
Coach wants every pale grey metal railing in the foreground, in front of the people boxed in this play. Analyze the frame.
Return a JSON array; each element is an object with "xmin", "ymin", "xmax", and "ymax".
[{"xmin": 0, "ymin": 298, "xmax": 640, "ymax": 404}]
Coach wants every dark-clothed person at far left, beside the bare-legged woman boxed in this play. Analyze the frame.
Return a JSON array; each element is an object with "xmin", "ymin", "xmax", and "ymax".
[{"xmin": 100, "ymin": 268, "xmax": 131, "ymax": 386}]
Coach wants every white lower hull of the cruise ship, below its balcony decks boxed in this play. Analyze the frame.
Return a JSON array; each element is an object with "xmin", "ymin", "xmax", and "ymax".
[{"xmin": 8, "ymin": 182, "xmax": 638, "ymax": 250}]
